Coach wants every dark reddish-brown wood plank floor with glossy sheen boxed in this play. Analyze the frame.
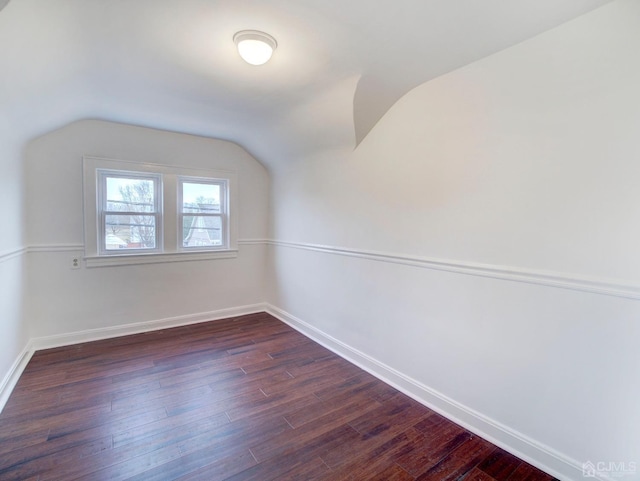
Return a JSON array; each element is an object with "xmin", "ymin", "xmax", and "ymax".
[{"xmin": 0, "ymin": 314, "xmax": 552, "ymax": 481}]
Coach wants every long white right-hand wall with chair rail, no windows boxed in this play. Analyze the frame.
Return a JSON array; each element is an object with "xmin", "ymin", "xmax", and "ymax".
[{"xmin": 269, "ymin": 0, "xmax": 640, "ymax": 479}]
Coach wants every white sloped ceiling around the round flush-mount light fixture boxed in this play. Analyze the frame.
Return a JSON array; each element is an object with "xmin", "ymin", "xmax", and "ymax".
[{"xmin": 0, "ymin": 0, "xmax": 610, "ymax": 165}]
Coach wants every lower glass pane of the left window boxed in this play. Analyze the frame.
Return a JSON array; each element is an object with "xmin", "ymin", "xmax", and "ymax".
[{"xmin": 105, "ymin": 215, "xmax": 156, "ymax": 250}]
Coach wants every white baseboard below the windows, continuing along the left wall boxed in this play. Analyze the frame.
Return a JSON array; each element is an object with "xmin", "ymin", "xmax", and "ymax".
[{"xmin": 0, "ymin": 303, "xmax": 267, "ymax": 412}]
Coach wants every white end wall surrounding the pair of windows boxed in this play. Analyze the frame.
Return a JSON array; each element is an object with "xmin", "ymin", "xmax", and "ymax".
[{"xmin": 25, "ymin": 120, "xmax": 269, "ymax": 340}]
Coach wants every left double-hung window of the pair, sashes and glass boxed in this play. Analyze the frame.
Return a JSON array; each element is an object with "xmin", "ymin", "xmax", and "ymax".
[{"xmin": 98, "ymin": 170, "xmax": 162, "ymax": 255}]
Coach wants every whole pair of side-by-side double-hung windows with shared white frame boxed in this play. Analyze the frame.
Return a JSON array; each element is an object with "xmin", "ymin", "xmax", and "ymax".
[{"xmin": 84, "ymin": 157, "xmax": 237, "ymax": 267}]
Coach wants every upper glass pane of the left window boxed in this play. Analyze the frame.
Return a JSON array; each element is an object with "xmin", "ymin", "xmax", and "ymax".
[{"xmin": 106, "ymin": 177, "xmax": 155, "ymax": 212}]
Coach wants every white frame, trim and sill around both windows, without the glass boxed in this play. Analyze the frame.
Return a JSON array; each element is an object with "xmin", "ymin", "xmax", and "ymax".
[{"xmin": 83, "ymin": 155, "xmax": 238, "ymax": 267}]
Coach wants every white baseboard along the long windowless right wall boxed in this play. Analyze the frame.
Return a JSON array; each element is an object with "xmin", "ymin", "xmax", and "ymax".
[{"xmin": 267, "ymin": 305, "xmax": 605, "ymax": 481}]
